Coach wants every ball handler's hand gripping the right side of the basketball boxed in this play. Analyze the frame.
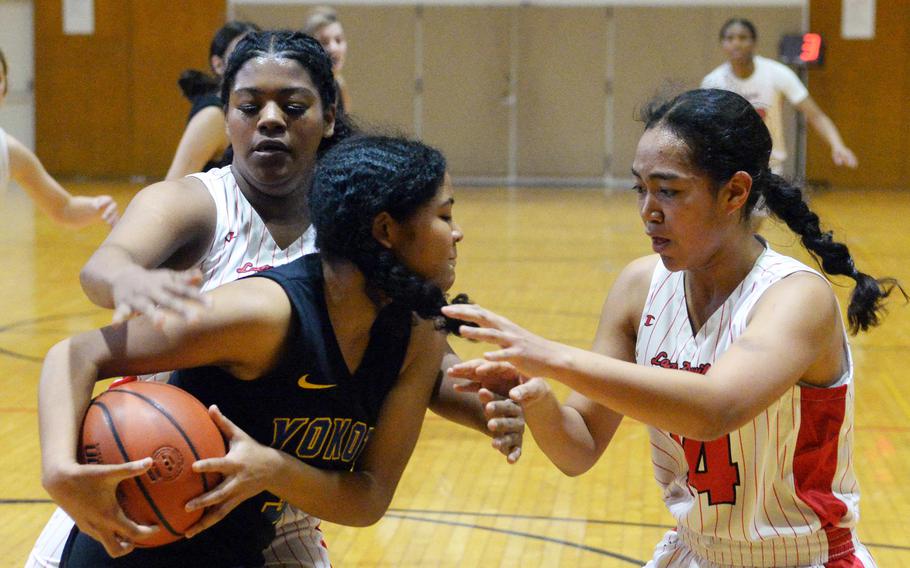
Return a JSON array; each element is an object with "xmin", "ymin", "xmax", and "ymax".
[{"xmin": 185, "ymin": 405, "xmax": 274, "ymax": 538}]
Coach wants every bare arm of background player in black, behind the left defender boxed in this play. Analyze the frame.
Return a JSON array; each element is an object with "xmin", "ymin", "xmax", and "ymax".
[{"xmin": 164, "ymin": 106, "xmax": 228, "ymax": 181}]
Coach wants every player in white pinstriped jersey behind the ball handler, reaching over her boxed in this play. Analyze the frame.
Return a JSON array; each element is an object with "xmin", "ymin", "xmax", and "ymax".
[{"xmin": 26, "ymin": 32, "xmax": 523, "ymax": 568}]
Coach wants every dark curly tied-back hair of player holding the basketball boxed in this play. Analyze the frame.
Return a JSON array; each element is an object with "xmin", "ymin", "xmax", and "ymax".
[{"xmin": 309, "ymin": 136, "xmax": 468, "ymax": 333}]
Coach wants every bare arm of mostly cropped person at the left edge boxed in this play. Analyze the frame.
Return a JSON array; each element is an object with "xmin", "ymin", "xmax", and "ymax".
[{"xmin": 6, "ymin": 135, "xmax": 120, "ymax": 229}]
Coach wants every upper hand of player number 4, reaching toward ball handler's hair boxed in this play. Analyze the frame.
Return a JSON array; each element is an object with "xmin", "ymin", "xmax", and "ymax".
[{"xmin": 442, "ymin": 304, "xmax": 561, "ymax": 377}]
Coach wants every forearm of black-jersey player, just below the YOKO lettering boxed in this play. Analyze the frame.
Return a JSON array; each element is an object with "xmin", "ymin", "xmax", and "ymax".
[{"xmin": 267, "ymin": 450, "xmax": 395, "ymax": 527}]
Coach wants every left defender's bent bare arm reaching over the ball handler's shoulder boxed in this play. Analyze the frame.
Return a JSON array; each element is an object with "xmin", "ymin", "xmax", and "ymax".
[{"xmin": 79, "ymin": 179, "xmax": 216, "ymax": 323}]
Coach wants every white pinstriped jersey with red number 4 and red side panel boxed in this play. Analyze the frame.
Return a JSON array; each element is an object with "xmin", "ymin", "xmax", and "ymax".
[{"xmin": 635, "ymin": 247, "xmax": 859, "ymax": 566}]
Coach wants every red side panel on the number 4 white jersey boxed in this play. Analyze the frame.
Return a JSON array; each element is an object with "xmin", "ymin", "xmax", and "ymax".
[{"xmin": 793, "ymin": 385, "xmax": 862, "ymax": 566}]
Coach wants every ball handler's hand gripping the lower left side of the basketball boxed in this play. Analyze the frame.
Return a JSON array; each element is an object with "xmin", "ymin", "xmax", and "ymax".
[{"xmin": 44, "ymin": 458, "xmax": 160, "ymax": 558}]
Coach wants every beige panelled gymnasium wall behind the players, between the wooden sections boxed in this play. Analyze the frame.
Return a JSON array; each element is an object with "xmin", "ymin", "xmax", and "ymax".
[{"xmin": 232, "ymin": 0, "xmax": 802, "ymax": 181}]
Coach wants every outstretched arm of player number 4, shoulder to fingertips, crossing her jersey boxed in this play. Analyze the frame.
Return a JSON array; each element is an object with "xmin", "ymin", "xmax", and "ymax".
[{"xmin": 444, "ymin": 273, "xmax": 843, "ymax": 440}]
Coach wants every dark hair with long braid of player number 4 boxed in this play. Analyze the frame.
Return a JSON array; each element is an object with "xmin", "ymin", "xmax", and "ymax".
[{"xmin": 642, "ymin": 89, "xmax": 907, "ymax": 334}]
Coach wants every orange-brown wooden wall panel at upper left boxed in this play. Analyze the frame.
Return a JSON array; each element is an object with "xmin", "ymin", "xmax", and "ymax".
[{"xmin": 35, "ymin": 0, "xmax": 225, "ymax": 177}]
